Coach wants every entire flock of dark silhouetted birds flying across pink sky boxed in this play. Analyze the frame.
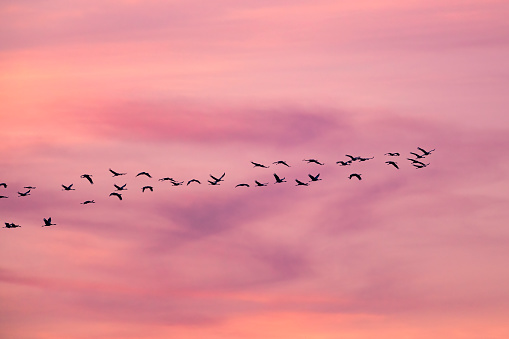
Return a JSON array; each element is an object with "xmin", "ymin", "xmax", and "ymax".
[{"xmin": 0, "ymin": 147, "xmax": 435, "ymax": 228}]
